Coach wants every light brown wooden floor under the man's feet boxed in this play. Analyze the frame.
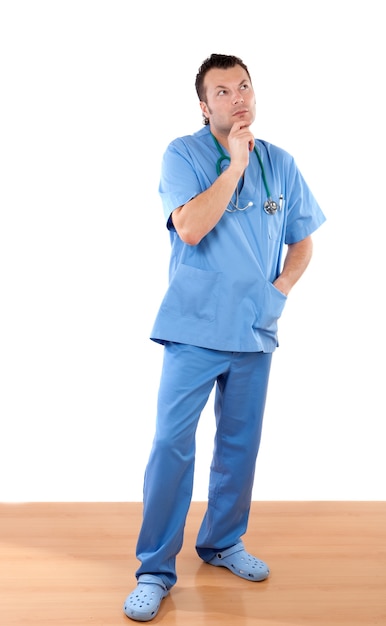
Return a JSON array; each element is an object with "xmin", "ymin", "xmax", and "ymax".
[{"xmin": 0, "ymin": 502, "xmax": 386, "ymax": 626}]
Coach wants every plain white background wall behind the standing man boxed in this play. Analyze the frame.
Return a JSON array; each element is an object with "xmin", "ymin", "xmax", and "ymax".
[{"xmin": 0, "ymin": 0, "xmax": 386, "ymax": 502}]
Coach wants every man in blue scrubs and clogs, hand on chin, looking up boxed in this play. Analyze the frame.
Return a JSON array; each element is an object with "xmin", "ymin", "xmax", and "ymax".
[{"xmin": 124, "ymin": 54, "xmax": 325, "ymax": 621}]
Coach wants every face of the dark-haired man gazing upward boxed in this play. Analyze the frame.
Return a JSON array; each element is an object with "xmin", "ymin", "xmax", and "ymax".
[{"xmin": 200, "ymin": 65, "xmax": 256, "ymax": 135}]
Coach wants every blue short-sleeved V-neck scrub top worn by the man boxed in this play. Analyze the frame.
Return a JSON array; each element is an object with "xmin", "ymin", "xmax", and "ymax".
[{"xmin": 151, "ymin": 126, "xmax": 326, "ymax": 352}]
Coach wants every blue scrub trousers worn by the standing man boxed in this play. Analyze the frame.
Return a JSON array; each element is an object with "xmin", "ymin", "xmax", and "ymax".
[{"xmin": 136, "ymin": 343, "xmax": 272, "ymax": 589}]
